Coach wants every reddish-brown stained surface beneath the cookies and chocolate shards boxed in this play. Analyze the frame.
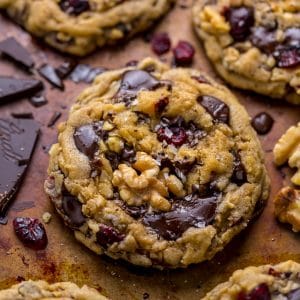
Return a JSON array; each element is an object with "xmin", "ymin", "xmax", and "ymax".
[{"xmin": 0, "ymin": 1, "xmax": 300, "ymax": 300}]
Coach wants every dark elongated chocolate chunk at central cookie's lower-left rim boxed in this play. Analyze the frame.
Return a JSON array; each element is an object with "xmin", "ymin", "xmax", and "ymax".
[{"xmin": 62, "ymin": 189, "xmax": 85, "ymax": 228}]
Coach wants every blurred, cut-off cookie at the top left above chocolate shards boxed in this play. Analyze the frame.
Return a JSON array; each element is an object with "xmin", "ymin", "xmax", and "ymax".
[{"xmin": 0, "ymin": 0, "xmax": 174, "ymax": 56}]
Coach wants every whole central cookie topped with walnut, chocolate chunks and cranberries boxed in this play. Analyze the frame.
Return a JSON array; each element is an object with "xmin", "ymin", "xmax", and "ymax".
[{"xmin": 45, "ymin": 58, "xmax": 269, "ymax": 268}]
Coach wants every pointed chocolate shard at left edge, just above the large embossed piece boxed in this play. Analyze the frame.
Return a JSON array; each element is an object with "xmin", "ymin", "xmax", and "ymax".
[{"xmin": 0, "ymin": 76, "xmax": 43, "ymax": 103}]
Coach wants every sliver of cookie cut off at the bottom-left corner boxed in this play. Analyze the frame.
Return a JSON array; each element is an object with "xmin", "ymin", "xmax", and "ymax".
[{"xmin": 0, "ymin": 280, "xmax": 107, "ymax": 300}]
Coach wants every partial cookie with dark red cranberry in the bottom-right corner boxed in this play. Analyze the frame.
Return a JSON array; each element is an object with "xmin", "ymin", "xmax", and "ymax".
[{"xmin": 202, "ymin": 260, "xmax": 300, "ymax": 300}]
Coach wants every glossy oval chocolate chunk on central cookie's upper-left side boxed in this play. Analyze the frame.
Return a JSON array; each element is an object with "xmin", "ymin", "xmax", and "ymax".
[{"xmin": 74, "ymin": 124, "xmax": 99, "ymax": 159}]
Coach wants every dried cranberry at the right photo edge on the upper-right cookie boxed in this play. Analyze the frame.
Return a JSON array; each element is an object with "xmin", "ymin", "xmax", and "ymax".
[{"xmin": 273, "ymin": 47, "xmax": 300, "ymax": 68}]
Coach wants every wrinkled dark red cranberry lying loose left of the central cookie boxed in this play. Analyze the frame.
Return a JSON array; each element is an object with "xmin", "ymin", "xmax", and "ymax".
[{"xmin": 13, "ymin": 217, "xmax": 48, "ymax": 250}]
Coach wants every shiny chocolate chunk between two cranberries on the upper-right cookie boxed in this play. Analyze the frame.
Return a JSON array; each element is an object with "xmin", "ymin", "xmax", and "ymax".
[{"xmin": 250, "ymin": 27, "xmax": 278, "ymax": 53}]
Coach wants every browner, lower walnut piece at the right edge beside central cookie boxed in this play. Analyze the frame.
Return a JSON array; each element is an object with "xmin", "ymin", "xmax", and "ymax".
[{"xmin": 274, "ymin": 187, "xmax": 300, "ymax": 232}]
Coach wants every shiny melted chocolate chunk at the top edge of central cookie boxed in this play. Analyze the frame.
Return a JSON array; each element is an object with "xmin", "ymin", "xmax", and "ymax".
[{"xmin": 115, "ymin": 70, "xmax": 161, "ymax": 105}]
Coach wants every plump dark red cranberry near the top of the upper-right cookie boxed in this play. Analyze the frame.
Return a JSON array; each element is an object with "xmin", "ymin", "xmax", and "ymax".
[{"xmin": 224, "ymin": 6, "xmax": 254, "ymax": 42}]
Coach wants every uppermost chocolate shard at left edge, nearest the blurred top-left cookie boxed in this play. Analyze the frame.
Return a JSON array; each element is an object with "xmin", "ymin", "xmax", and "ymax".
[{"xmin": 0, "ymin": 37, "xmax": 34, "ymax": 69}]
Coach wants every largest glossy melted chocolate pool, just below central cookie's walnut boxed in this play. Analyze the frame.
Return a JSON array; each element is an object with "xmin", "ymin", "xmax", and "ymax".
[{"xmin": 142, "ymin": 194, "xmax": 218, "ymax": 240}]
